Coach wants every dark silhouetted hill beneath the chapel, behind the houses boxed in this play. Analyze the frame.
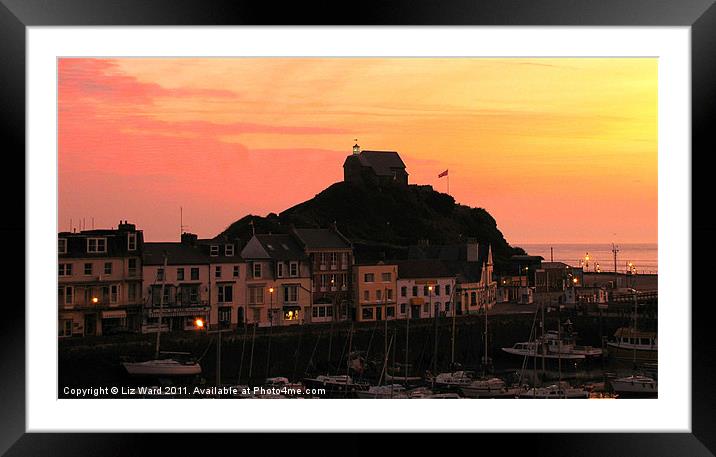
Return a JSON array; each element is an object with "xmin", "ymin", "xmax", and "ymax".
[{"xmin": 219, "ymin": 182, "xmax": 524, "ymax": 270}]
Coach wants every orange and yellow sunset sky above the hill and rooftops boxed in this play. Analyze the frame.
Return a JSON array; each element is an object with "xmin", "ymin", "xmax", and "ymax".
[{"xmin": 59, "ymin": 58, "xmax": 657, "ymax": 244}]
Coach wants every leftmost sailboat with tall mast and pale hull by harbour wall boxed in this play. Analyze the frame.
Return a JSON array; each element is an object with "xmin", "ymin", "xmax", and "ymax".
[{"xmin": 122, "ymin": 253, "xmax": 201, "ymax": 377}]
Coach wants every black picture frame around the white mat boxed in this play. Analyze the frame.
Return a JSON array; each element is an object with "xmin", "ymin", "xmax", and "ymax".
[{"xmin": 0, "ymin": 0, "xmax": 716, "ymax": 457}]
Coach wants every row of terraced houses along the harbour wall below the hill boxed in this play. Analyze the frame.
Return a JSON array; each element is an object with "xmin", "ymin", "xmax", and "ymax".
[{"xmin": 58, "ymin": 221, "xmax": 497, "ymax": 337}]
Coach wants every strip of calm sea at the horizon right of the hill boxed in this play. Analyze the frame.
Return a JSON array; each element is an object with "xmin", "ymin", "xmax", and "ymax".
[{"xmin": 513, "ymin": 243, "xmax": 659, "ymax": 274}]
